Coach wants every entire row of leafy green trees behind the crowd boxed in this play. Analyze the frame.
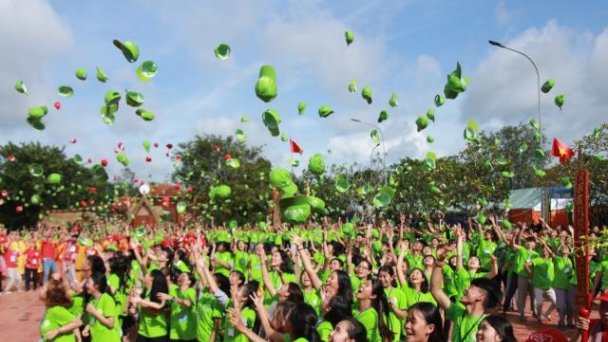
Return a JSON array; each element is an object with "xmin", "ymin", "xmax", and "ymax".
[{"xmin": 0, "ymin": 124, "xmax": 608, "ymax": 227}]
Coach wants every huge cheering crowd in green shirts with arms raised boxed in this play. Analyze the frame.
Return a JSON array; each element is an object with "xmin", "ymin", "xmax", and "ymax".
[{"xmin": 0, "ymin": 215, "xmax": 608, "ymax": 342}]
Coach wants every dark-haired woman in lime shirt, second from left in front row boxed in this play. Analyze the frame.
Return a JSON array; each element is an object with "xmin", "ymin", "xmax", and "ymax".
[{"xmin": 82, "ymin": 273, "xmax": 120, "ymax": 342}]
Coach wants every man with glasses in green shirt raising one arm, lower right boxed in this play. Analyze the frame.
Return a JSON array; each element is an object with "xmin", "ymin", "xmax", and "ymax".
[{"xmin": 431, "ymin": 243, "xmax": 502, "ymax": 342}]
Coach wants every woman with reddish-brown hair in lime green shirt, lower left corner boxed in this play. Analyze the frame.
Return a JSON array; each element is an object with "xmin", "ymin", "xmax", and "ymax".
[{"xmin": 40, "ymin": 279, "xmax": 82, "ymax": 342}]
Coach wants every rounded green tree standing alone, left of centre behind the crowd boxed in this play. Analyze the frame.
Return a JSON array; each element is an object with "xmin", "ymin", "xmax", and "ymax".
[{"xmin": 172, "ymin": 135, "xmax": 272, "ymax": 223}]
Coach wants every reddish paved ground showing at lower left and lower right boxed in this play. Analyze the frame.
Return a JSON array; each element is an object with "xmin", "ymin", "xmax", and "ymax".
[{"xmin": 0, "ymin": 291, "xmax": 598, "ymax": 342}]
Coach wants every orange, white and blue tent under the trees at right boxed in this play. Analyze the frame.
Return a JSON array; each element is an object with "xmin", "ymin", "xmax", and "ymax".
[{"xmin": 507, "ymin": 187, "xmax": 572, "ymax": 227}]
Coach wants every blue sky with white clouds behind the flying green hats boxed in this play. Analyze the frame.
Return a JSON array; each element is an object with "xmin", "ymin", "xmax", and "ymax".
[{"xmin": 0, "ymin": 0, "xmax": 608, "ymax": 186}]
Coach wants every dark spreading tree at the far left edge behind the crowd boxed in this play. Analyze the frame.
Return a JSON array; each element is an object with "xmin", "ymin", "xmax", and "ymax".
[{"xmin": 0, "ymin": 142, "xmax": 112, "ymax": 228}]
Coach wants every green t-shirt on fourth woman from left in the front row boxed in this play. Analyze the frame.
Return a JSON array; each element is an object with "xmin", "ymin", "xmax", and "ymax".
[{"xmin": 169, "ymin": 287, "xmax": 196, "ymax": 341}]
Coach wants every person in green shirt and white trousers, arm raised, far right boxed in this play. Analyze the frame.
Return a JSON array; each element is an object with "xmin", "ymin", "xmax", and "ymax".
[{"xmin": 525, "ymin": 240, "xmax": 556, "ymax": 322}]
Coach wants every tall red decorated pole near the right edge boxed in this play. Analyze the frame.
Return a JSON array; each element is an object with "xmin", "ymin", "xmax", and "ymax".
[{"xmin": 574, "ymin": 170, "xmax": 591, "ymax": 341}]
